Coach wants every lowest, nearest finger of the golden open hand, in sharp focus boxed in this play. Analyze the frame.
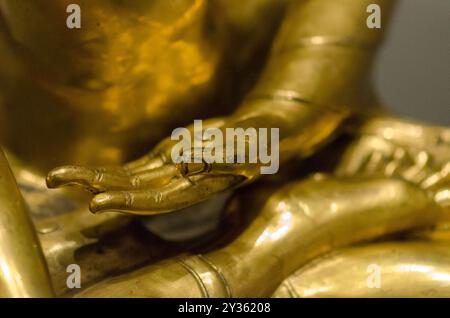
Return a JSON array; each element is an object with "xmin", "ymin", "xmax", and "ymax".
[{"xmin": 89, "ymin": 176, "xmax": 242, "ymax": 215}]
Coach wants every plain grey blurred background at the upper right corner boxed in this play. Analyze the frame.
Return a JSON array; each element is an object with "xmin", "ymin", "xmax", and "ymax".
[{"xmin": 375, "ymin": 0, "xmax": 450, "ymax": 125}]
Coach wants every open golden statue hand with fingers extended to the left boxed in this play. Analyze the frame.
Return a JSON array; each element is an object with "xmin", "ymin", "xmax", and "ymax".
[{"xmin": 47, "ymin": 119, "xmax": 259, "ymax": 215}]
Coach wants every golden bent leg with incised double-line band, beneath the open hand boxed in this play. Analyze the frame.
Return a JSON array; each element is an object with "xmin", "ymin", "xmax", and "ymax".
[{"xmin": 75, "ymin": 171, "xmax": 448, "ymax": 297}]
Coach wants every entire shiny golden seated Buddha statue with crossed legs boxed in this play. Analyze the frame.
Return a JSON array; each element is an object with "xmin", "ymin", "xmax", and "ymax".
[{"xmin": 0, "ymin": 0, "xmax": 450, "ymax": 297}]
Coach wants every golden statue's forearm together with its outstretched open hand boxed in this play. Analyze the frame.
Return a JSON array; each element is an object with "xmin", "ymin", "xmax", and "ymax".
[{"xmin": 40, "ymin": 1, "xmax": 391, "ymax": 214}]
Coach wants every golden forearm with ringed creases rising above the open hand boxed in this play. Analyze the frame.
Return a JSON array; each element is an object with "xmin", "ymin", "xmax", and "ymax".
[{"xmin": 230, "ymin": 0, "xmax": 395, "ymax": 158}]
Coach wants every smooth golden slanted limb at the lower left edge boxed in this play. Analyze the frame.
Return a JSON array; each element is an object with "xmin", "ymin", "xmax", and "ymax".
[{"xmin": 0, "ymin": 150, "xmax": 53, "ymax": 297}]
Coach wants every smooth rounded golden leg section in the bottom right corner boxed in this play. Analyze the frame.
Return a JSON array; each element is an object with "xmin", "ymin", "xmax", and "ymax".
[{"xmin": 273, "ymin": 242, "xmax": 450, "ymax": 298}]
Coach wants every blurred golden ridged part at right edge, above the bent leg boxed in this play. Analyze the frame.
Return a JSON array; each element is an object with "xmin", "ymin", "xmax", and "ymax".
[{"xmin": 336, "ymin": 118, "xmax": 450, "ymax": 207}]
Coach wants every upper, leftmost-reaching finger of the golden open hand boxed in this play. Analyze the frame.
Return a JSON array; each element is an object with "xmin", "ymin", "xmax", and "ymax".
[{"xmin": 46, "ymin": 166, "xmax": 131, "ymax": 193}]
